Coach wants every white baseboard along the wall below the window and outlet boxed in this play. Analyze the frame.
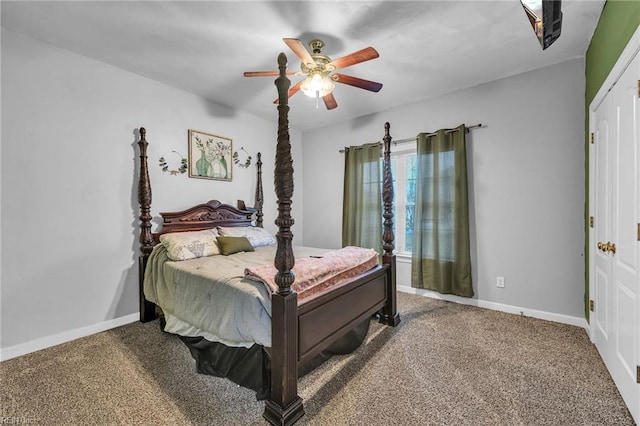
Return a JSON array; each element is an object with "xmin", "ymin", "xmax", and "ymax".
[{"xmin": 397, "ymin": 285, "xmax": 589, "ymax": 333}]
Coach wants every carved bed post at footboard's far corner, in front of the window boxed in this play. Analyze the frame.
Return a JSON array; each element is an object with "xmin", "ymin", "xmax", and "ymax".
[{"xmin": 380, "ymin": 122, "xmax": 400, "ymax": 327}]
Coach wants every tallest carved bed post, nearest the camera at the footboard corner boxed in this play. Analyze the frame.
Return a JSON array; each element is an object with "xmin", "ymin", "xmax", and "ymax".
[{"xmin": 263, "ymin": 53, "xmax": 304, "ymax": 425}]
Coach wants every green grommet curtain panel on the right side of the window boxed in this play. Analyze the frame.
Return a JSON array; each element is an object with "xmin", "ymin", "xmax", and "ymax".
[{"xmin": 411, "ymin": 124, "xmax": 473, "ymax": 297}]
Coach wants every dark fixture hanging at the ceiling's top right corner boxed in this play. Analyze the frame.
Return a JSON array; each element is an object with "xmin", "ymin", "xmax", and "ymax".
[{"xmin": 520, "ymin": 0, "xmax": 562, "ymax": 50}]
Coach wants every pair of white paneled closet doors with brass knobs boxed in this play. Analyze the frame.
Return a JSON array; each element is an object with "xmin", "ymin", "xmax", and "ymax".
[{"xmin": 592, "ymin": 46, "xmax": 640, "ymax": 421}]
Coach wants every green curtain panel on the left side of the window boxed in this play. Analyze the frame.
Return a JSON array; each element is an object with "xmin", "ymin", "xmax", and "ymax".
[{"xmin": 342, "ymin": 143, "xmax": 382, "ymax": 253}]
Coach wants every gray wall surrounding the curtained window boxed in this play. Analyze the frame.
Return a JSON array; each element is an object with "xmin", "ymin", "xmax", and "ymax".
[{"xmin": 303, "ymin": 59, "xmax": 585, "ymax": 323}]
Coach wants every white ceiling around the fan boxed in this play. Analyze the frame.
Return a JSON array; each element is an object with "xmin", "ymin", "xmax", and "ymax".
[{"xmin": 0, "ymin": 0, "xmax": 604, "ymax": 130}]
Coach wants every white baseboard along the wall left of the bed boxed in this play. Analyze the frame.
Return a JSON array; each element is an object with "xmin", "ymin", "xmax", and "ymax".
[{"xmin": 0, "ymin": 312, "xmax": 140, "ymax": 361}]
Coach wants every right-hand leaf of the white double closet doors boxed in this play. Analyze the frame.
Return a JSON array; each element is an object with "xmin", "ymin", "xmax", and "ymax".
[{"xmin": 610, "ymin": 47, "xmax": 640, "ymax": 419}]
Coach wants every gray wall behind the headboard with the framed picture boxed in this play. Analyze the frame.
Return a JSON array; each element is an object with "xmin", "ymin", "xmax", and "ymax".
[{"xmin": 0, "ymin": 29, "xmax": 303, "ymax": 355}]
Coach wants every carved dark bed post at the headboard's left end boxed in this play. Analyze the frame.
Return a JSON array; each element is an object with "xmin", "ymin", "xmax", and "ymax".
[{"xmin": 138, "ymin": 127, "xmax": 156, "ymax": 322}]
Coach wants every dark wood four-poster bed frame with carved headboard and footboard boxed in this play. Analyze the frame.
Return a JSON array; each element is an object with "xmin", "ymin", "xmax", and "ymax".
[{"xmin": 138, "ymin": 53, "xmax": 400, "ymax": 425}]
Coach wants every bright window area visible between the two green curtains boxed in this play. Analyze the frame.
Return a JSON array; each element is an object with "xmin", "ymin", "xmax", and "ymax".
[{"xmin": 381, "ymin": 146, "xmax": 416, "ymax": 254}]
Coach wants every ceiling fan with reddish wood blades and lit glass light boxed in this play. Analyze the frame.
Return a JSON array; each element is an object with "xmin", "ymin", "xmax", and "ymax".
[{"xmin": 244, "ymin": 38, "xmax": 382, "ymax": 109}]
